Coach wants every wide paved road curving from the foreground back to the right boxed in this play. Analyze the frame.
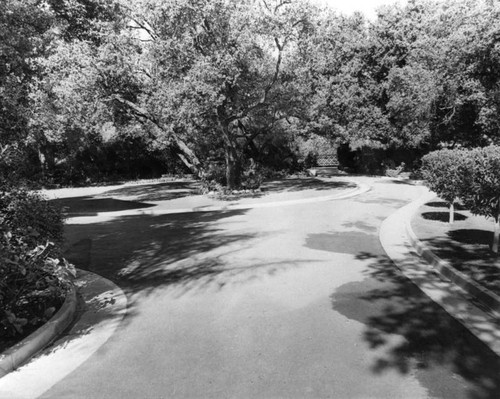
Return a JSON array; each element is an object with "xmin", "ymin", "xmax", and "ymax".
[{"xmin": 5, "ymin": 178, "xmax": 500, "ymax": 399}]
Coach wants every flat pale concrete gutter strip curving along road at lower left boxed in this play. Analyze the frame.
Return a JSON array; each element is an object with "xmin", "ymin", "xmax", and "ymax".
[{"xmin": 0, "ymin": 269, "xmax": 127, "ymax": 399}]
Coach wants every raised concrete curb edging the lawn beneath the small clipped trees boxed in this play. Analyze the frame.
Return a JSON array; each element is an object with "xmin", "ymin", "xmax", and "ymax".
[{"xmin": 406, "ymin": 203, "xmax": 500, "ymax": 319}]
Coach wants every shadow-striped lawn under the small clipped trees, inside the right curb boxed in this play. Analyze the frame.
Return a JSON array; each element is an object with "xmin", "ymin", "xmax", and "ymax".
[{"xmin": 411, "ymin": 200, "xmax": 500, "ymax": 295}]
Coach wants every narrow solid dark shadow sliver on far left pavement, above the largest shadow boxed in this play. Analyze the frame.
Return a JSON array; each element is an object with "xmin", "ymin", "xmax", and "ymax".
[{"xmin": 50, "ymin": 196, "xmax": 154, "ymax": 217}]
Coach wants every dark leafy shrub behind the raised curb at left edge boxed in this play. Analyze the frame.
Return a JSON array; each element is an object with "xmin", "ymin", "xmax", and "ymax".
[{"xmin": 0, "ymin": 188, "xmax": 74, "ymax": 337}]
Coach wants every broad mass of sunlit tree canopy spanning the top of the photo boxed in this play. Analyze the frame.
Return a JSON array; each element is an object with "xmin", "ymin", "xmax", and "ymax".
[{"xmin": 0, "ymin": 0, "xmax": 500, "ymax": 187}]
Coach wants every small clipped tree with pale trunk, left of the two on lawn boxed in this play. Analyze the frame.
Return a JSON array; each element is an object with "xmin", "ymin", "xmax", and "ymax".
[{"xmin": 422, "ymin": 149, "xmax": 467, "ymax": 223}]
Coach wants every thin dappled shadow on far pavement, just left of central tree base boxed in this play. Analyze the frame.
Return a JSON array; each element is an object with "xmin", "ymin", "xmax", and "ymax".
[{"xmin": 101, "ymin": 182, "xmax": 200, "ymax": 202}]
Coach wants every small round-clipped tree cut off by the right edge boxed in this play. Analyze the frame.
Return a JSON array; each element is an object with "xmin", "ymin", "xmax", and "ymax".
[{"xmin": 460, "ymin": 145, "xmax": 500, "ymax": 253}]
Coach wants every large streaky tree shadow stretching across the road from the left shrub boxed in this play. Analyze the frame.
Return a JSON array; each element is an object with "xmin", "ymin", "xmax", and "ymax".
[{"xmin": 65, "ymin": 210, "xmax": 292, "ymax": 304}]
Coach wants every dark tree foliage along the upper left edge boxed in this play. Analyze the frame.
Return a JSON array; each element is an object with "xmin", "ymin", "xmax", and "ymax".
[{"xmin": 0, "ymin": 0, "xmax": 53, "ymax": 184}]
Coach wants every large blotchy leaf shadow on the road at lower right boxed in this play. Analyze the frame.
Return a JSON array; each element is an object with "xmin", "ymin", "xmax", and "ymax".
[{"xmin": 332, "ymin": 253, "xmax": 500, "ymax": 398}]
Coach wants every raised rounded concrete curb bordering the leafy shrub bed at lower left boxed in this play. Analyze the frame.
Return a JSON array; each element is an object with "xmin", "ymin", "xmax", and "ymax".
[{"xmin": 0, "ymin": 285, "xmax": 77, "ymax": 378}]
